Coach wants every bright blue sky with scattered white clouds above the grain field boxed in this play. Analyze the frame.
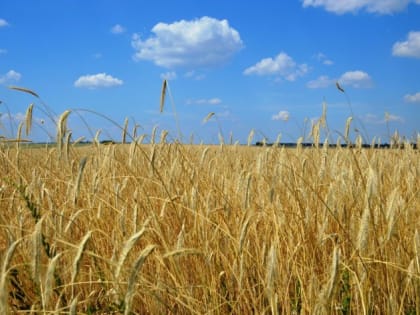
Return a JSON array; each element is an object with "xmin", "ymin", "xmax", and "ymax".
[{"xmin": 0, "ymin": 0, "xmax": 420, "ymax": 143}]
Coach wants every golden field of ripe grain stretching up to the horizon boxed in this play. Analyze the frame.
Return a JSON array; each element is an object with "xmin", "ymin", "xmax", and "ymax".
[{"xmin": 0, "ymin": 143, "xmax": 420, "ymax": 314}]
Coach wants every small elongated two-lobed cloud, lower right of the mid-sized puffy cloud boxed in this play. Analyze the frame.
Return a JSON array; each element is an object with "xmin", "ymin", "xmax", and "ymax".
[{"xmin": 306, "ymin": 70, "xmax": 372, "ymax": 89}]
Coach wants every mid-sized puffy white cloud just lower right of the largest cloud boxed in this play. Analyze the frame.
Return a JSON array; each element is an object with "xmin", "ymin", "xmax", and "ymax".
[{"xmin": 244, "ymin": 52, "xmax": 308, "ymax": 81}]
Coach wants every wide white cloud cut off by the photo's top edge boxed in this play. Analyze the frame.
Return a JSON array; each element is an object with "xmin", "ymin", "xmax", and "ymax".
[{"xmin": 302, "ymin": 0, "xmax": 420, "ymax": 14}]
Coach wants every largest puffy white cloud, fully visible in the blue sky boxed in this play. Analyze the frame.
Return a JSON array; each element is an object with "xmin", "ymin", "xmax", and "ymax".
[{"xmin": 131, "ymin": 16, "xmax": 243, "ymax": 69}]
